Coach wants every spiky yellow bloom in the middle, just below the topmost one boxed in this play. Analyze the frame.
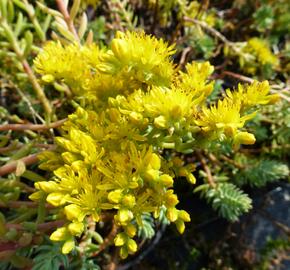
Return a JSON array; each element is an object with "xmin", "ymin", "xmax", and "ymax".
[{"xmin": 110, "ymin": 87, "xmax": 203, "ymax": 135}]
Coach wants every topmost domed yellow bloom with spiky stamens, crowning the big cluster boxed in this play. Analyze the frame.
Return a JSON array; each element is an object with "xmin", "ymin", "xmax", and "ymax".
[{"xmin": 99, "ymin": 32, "xmax": 175, "ymax": 86}]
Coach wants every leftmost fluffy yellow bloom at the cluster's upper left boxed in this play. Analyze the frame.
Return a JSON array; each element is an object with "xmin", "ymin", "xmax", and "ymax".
[{"xmin": 34, "ymin": 41, "xmax": 103, "ymax": 95}]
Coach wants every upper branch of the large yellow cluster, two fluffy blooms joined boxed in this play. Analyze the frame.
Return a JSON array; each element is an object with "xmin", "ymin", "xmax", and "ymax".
[{"xmin": 34, "ymin": 32, "xmax": 175, "ymax": 99}]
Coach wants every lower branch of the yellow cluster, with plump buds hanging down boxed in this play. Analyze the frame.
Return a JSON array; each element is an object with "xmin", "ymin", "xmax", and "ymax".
[{"xmin": 30, "ymin": 107, "xmax": 191, "ymax": 255}]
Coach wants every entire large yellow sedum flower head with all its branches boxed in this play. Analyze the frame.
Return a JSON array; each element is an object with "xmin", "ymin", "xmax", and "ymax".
[{"xmin": 30, "ymin": 32, "xmax": 275, "ymax": 258}]
